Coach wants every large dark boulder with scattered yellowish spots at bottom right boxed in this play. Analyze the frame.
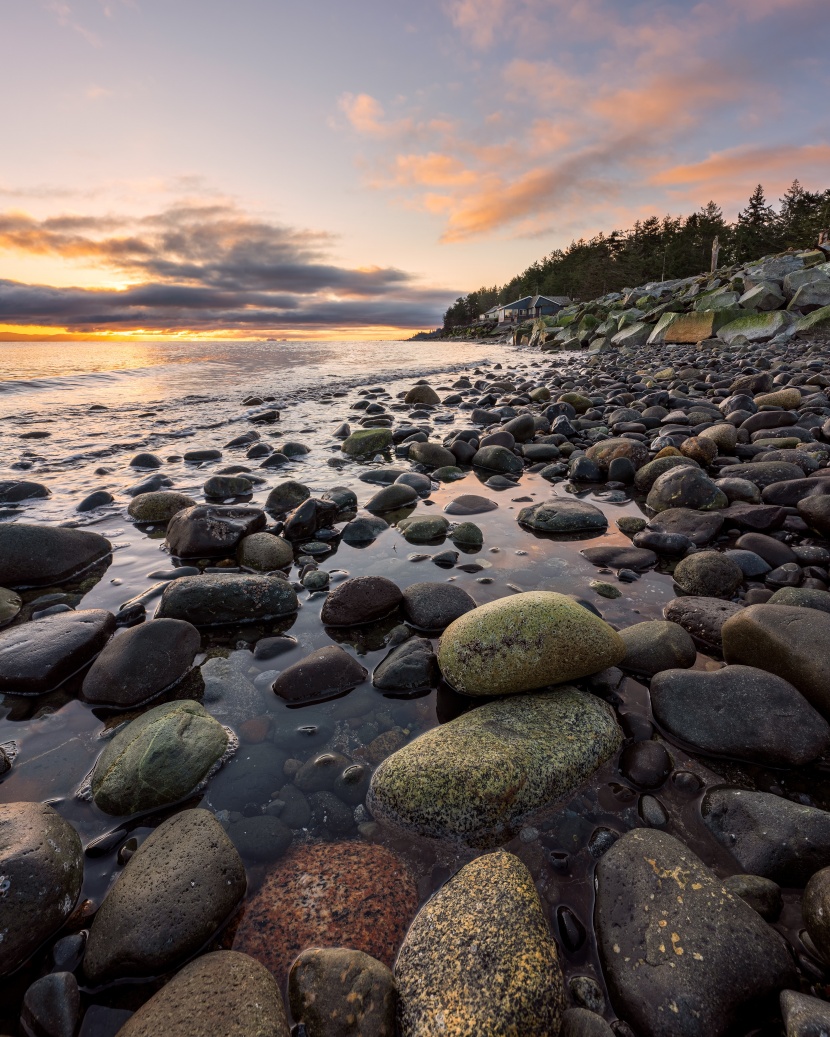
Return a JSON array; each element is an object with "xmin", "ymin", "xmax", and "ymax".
[{"xmin": 594, "ymin": 829, "xmax": 795, "ymax": 1037}]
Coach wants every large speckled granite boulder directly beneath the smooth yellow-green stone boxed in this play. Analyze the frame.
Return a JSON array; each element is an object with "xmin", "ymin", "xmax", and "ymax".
[{"xmin": 367, "ymin": 688, "xmax": 623, "ymax": 845}]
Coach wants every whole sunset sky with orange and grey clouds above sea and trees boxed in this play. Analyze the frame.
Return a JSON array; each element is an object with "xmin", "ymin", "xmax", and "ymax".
[{"xmin": 0, "ymin": 0, "xmax": 830, "ymax": 339}]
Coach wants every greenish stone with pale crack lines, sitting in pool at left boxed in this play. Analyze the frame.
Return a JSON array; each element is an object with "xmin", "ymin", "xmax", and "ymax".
[{"xmin": 92, "ymin": 700, "xmax": 228, "ymax": 814}]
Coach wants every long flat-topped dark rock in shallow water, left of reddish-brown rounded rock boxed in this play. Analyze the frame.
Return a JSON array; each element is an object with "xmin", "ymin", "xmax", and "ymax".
[{"xmin": 156, "ymin": 572, "xmax": 298, "ymax": 626}]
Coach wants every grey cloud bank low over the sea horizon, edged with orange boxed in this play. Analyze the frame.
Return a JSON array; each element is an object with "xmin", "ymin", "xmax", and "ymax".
[{"xmin": 0, "ymin": 205, "xmax": 450, "ymax": 334}]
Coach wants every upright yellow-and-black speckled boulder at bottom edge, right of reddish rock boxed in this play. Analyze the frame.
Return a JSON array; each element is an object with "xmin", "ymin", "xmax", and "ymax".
[{"xmin": 395, "ymin": 850, "xmax": 564, "ymax": 1037}]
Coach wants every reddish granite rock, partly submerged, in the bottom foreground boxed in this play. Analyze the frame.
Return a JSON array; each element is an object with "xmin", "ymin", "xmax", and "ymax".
[{"xmin": 233, "ymin": 842, "xmax": 418, "ymax": 984}]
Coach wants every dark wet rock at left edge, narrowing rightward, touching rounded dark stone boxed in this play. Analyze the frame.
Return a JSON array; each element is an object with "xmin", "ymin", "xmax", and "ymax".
[{"xmin": 0, "ymin": 609, "xmax": 115, "ymax": 695}]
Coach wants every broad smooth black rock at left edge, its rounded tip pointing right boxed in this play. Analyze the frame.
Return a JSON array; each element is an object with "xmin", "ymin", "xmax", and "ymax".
[{"xmin": 0, "ymin": 523, "xmax": 112, "ymax": 590}]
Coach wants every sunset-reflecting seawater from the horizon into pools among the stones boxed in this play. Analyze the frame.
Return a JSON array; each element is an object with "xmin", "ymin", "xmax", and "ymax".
[{"xmin": 0, "ymin": 342, "xmax": 824, "ymax": 1037}]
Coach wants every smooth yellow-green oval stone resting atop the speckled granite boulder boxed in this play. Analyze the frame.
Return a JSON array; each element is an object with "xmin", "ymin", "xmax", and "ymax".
[{"xmin": 438, "ymin": 591, "xmax": 626, "ymax": 696}]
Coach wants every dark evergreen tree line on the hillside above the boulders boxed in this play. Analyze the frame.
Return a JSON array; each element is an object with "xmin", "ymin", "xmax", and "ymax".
[{"xmin": 444, "ymin": 180, "xmax": 830, "ymax": 330}]
